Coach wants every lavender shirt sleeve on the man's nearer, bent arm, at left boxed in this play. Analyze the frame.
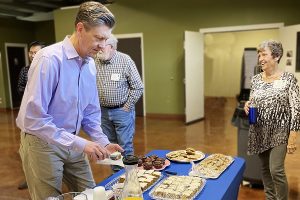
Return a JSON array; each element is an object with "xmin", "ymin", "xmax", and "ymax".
[{"xmin": 17, "ymin": 56, "xmax": 87, "ymax": 152}]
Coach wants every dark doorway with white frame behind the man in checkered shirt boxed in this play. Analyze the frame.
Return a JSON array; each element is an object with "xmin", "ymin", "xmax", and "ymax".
[{"xmin": 116, "ymin": 33, "xmax": 146, "ymax": 117}]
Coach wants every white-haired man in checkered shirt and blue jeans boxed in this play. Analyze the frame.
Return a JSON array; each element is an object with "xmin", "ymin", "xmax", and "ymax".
[{"xmin": 95, "ymin": 35, "xmax": 144, "ymax": 169}]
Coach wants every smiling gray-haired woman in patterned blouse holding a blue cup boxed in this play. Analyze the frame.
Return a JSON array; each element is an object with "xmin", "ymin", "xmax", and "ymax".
[{"xmin": 245, "ymin": 40, "xmax": 300, "ymax": 200}]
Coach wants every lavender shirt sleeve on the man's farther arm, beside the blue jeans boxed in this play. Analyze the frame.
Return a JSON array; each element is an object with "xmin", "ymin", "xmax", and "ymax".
[{"xmin": 81, "ymin": 84, "xmax": 110, "ymax": 147}]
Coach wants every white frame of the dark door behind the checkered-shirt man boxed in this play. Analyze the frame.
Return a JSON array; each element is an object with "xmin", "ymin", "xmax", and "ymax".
[{"xmin": 114, "ymin": 33, "xmax": 146, "ymax": 117}]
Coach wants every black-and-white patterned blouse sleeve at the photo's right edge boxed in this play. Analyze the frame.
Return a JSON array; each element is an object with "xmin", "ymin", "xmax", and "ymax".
[{"xmin": 289, "ymin": 75, "xmax": 300, "ymax": 131}]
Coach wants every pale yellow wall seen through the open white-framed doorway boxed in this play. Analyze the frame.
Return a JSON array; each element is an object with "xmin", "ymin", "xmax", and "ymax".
[{"xmin": 204, "ymin": 29, "xmax": 279, "ymax": 98}]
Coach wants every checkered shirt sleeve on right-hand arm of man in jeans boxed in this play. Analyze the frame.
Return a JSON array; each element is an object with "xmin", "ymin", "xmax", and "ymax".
[{"xmin": 125, "ymin": 57, "xmax": 144, "ymax": 109}]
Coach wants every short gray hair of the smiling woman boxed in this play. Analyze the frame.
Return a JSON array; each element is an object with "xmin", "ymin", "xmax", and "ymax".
[{"xmin": 257, "ymin": 39, "xmax": 283, "ymax": 63}]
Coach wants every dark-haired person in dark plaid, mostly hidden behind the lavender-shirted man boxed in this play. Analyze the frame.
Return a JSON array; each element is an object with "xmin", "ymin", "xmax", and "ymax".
[{"xmin": 18, "ymin": 41, "xmax": 45, "ymax": 97}]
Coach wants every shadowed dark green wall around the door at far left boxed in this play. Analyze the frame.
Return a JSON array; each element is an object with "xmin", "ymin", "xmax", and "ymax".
[{"xmin": 0, "ymin": 18, "xmax": 55, "ymax": 108}]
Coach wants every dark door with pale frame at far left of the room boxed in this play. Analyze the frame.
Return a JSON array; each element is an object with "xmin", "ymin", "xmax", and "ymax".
[{"xmin": 5, "ymin": 43, "xmax": 28, "ymax": 108}]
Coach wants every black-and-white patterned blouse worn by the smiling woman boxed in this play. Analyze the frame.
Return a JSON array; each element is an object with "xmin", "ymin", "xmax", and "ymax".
[{"xmin": 248, "ymin": 72, "xmax": 300, "ymax": 155}]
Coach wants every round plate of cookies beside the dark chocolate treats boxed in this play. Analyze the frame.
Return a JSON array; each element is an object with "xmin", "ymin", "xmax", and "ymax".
[{"xmin": 166, "ymin": 148, "xmax": 205, "ymax": 163}]
